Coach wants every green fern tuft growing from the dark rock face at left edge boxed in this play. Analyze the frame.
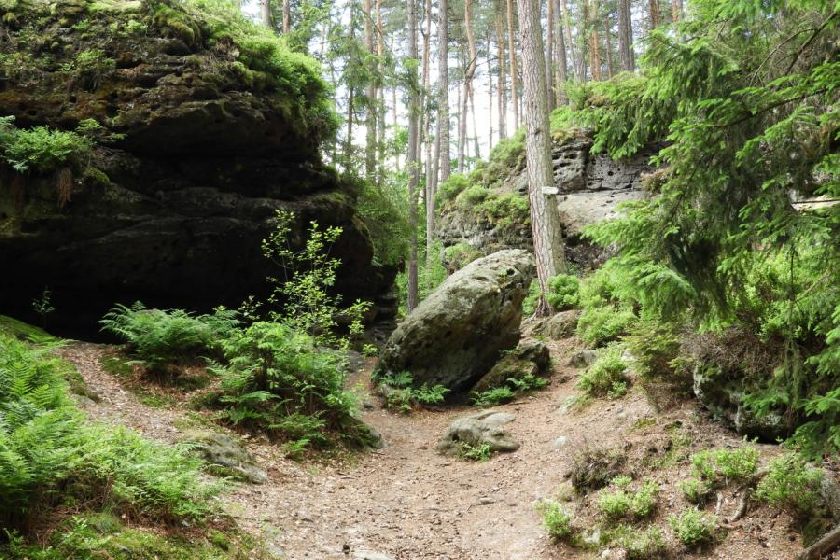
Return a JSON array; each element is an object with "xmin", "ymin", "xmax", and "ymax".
[{"xmin": 0, "ymin": 117, "xmax": 94, "ymax": 173}]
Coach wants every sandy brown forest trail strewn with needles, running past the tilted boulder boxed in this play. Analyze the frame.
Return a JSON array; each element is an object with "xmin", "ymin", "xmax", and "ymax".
[{"xmin": 59, "ymin": 339, "xmax": 801, "ymax": 560}]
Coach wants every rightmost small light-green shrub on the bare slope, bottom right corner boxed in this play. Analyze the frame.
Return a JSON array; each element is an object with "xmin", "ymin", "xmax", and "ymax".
[{"xmin": 755, "ymin": 454, "xmax": 823, "ymax": 518}]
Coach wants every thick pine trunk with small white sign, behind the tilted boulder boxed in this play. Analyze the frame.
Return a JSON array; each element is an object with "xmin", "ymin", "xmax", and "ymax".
[{"xmin": 518, "ymin": 0, "xmax": 565, "ymax": 315}]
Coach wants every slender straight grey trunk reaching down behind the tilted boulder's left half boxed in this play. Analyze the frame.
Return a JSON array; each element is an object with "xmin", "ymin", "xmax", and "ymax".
[{"xmin": 406, "ymin": 0, "xmax": 420, "ymax": 313}]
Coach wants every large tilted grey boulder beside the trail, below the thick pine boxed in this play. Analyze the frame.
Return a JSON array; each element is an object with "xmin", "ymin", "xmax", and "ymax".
[{"xmin": 377, "ymin": 250, "xmax": 534, "ymax": 393}]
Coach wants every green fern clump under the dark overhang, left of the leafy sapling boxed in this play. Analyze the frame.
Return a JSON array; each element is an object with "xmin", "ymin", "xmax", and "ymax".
[{"xmin": 100, "ymin": 301, "xmax": 238, "ymax": 372}]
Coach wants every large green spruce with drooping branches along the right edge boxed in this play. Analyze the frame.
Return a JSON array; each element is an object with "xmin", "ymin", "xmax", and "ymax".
[{"xmin": 571, "ymin": 0, "xmax": 840, "ymax": 457}]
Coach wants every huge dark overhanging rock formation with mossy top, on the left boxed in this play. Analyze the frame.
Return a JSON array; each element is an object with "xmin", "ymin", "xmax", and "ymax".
[{"xmin": 0, "ymin": 0, "xmax": 394, "ymax": 332}]
